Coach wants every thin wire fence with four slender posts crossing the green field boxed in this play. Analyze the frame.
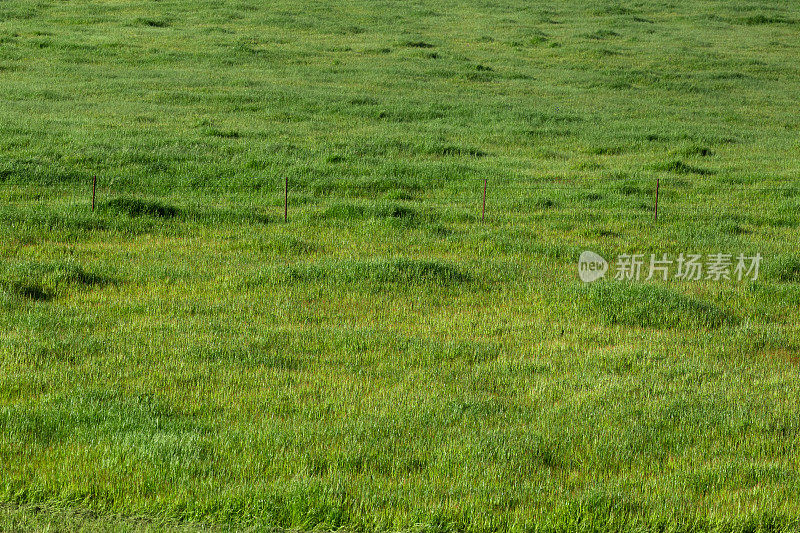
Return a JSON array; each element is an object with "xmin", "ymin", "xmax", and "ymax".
[{"xmin": 2, "ymin": 177, "xmax": 800, "ymax": 225}]
